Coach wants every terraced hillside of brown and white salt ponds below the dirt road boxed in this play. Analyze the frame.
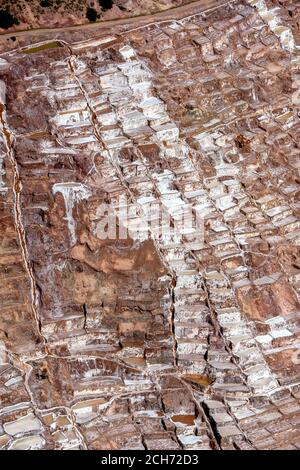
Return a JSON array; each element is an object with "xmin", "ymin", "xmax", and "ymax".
[{"xmin": 0, "ymin": 0, "xmax": 300, "ymax": 450}]
